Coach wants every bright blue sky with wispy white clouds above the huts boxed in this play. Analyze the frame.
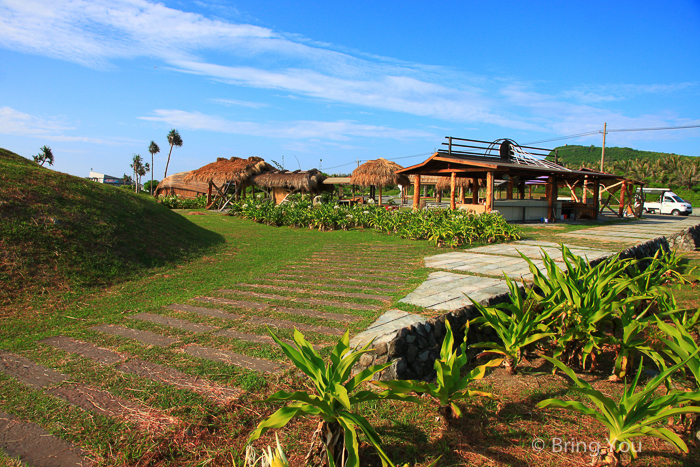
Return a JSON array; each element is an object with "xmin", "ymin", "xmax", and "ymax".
[{"xmin": 0, "ymin": 0, "xmax": 700, "ymax": 179}]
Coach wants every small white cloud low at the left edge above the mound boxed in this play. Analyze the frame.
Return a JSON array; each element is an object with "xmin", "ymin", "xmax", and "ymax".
[{"xmin": 0, "ymin": 107, "xmax": 128, "ymax": 145}]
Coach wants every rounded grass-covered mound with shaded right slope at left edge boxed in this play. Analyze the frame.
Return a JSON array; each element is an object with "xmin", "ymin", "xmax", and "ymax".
[{"xmin": 0, "ymin": 149, "xmax": 223, "ymax": 305}]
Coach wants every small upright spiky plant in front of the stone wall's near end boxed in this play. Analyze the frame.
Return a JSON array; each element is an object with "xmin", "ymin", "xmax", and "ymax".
[{"xmin": 372, "ymin": 321, "xmax": 503, "ymax": 422}]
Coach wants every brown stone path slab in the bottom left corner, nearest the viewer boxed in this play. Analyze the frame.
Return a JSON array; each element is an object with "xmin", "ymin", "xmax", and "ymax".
[{"xmin": 0, "ymin": 411, "xmax": 93, "ymax": 467}]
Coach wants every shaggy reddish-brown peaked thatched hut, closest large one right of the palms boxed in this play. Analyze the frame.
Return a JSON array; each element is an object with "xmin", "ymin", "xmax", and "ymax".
[{"xmin": 184, "ymin": 157, "xmax": 274, "ymax": 210}]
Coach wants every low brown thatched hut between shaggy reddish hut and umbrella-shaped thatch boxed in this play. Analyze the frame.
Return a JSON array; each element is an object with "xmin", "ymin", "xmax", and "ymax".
[{"xmin": 250, "ymin": 169, "xmax": 326, "ymax": 204}]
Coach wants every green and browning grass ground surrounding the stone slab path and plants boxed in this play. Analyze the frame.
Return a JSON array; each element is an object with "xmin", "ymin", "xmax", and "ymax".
[{"xmin": 0, "ymin": 207, "xmax": 700, "ymax": 466}]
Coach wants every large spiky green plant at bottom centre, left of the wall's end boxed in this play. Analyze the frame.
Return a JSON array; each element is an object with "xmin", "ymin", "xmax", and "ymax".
[{"xmin": 248, "ymin": 329, "xmax": 418, "ymax": 467}]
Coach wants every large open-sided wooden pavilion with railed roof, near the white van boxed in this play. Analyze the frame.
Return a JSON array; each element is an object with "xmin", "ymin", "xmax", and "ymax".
[{"xmin": 398, "ymin": 137, "xmax": 638, "ymax": 222}]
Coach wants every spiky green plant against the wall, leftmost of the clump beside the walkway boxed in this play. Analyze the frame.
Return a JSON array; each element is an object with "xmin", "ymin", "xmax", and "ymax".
[{"xmin": 470, "ymin": 276, "xmax": 555, "ymax": 374}]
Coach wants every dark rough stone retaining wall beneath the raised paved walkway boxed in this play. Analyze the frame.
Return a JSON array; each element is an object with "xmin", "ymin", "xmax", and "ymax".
[{"xmin": 354, "ymin": 221, "xmax": 700, "ymax": 381}]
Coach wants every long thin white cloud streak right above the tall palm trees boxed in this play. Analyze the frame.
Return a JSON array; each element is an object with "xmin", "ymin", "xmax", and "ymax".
[{"xmin": 139, "ymin": 109, "xmax": 436, "ymax": 141}]
